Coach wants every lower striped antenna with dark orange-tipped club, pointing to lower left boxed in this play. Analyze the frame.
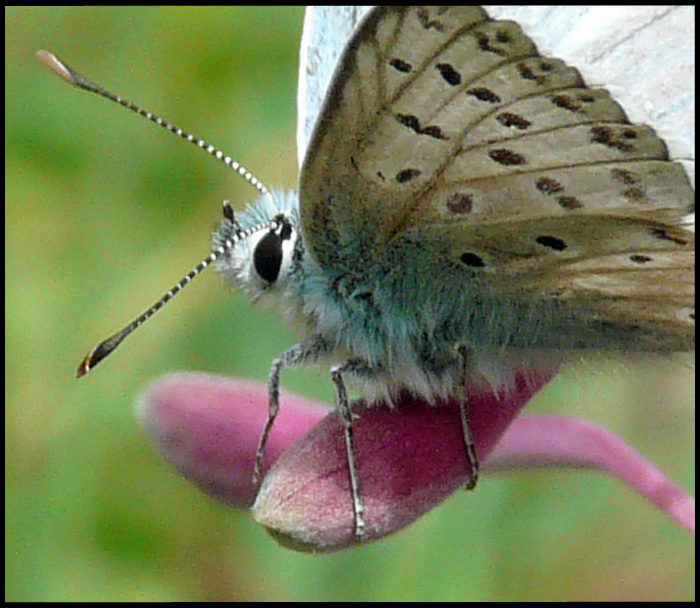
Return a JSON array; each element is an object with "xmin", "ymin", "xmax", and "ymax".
[{"xmin": 76, "ymin": 201, "xmax": 278, "ymax": 378}]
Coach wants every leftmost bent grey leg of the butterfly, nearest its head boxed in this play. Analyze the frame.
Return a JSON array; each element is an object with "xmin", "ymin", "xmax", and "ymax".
[{"xmin": 253, "ymin": 336, "xmax": 332, "ymax": 485}]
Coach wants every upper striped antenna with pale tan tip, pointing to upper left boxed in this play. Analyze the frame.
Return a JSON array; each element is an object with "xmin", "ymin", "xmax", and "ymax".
[{"xmin": 36, "ymin": 51, "xmax": 272, "ymax": 197}]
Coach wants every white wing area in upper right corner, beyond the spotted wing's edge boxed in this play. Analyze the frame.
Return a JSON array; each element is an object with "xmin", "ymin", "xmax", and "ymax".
[{"xmin": 484, "ymin": 6, "xmax": 695, "ymax": 187}]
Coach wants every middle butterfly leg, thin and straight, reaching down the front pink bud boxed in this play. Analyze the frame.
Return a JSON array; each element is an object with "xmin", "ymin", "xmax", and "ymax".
[{"xmin": 331, "ymin": 359, "xmax": 373, "ymax": 539}]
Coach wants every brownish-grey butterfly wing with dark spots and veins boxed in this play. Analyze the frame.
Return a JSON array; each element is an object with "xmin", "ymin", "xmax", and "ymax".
[{"xmin": 300, "ymin": 7, "xmax": 694, "ymax": 350}]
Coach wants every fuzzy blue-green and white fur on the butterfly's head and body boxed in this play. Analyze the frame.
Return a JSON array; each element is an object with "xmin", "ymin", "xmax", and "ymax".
[{"xmin": 219, "ymin": 192, "xmax": 660, "ymax": 399}]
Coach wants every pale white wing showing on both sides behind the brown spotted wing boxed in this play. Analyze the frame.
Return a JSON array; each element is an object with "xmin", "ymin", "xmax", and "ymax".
[{"xmin": 297, "ymin": 6, "xmax": 695, "ymax": 187}]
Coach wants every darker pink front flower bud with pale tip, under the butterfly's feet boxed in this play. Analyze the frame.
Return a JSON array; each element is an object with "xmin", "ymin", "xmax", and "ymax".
[{"xmin": 253, "ymin": 370, "xmax": 546, "ymax": 552}]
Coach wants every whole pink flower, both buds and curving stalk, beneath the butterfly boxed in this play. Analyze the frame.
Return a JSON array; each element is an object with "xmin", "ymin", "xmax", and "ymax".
[{"xmin": 139, "ymin": 373, "xmax": 695, "ymax": 551}]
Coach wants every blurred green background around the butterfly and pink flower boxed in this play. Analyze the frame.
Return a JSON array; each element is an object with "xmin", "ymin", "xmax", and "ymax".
[{"xmin": 5, "ymin": 8, "xmax": 695, "ymax": 601}]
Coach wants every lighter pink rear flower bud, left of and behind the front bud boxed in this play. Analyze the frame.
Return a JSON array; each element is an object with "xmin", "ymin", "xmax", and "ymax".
[{"xmin": 137, "ymin": 373, "xmax": 327, "ymax": 508}]
